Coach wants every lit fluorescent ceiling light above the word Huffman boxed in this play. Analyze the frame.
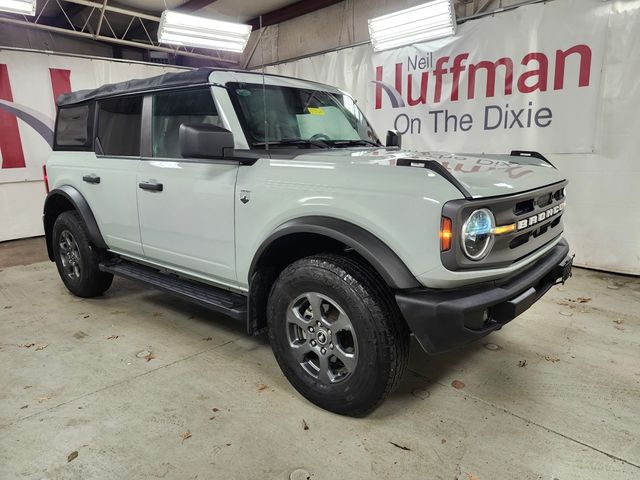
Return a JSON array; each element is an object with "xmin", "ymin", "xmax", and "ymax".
[{"xmin": 369, "ymin": 0, "xmax": 456, "ymax": 52}]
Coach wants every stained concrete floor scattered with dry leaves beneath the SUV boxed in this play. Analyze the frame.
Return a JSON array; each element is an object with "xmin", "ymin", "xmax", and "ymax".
[{"xmin": 0, "ymin": 240, "xmax": 640, "ymax": 480}]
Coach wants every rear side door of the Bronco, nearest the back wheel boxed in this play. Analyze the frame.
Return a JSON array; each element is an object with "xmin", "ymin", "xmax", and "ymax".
[{"xmin": 58, "ymin": 97, "xmax": 142, "ymax": 255}]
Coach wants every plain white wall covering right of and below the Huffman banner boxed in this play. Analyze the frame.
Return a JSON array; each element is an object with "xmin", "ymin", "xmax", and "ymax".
[{"xmin": 551, "ymin": 0, "xmax": 640, "ymax": 275}]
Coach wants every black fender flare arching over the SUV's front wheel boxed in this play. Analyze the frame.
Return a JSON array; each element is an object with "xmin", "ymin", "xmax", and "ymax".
[{"xmin": 249, "ymin": 216, "xmax": 420, "ymax": 290}]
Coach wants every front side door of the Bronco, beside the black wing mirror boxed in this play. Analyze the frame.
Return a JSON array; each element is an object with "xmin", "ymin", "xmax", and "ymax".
[{"xmin": 137, "ymin": 87, "xmax": 238, "ymax": 284}]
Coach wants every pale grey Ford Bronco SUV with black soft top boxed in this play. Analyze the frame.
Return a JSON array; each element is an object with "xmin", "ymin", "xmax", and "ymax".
[{"xmin": 44, "ymin": 69, "xmax": 572, "ymax": 415}]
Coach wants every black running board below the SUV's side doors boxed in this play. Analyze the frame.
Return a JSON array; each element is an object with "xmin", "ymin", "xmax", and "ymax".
[{"xmin": 100, "ymin": 259, "xmax": 247, "ymax": 320}]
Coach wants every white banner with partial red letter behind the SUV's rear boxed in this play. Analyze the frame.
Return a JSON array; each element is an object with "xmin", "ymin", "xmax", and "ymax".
[{"xmin": 0, "ymin": 49, "xmax": 185, "ymax": 183}]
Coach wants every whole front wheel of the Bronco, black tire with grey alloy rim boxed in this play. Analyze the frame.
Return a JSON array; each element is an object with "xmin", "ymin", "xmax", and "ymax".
[{"xmin": 268, "ymin": 255, "xmax": 409, "ymax": 416}]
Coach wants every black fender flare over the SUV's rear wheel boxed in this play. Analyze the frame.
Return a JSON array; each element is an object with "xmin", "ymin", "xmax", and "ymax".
[{"xmin": 42, "ymin": 185, "xmax": 108, "ymax": 261}]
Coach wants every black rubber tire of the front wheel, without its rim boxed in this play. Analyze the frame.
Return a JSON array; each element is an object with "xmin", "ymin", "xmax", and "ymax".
[{"xmin": 267, "ymin": 254, "xmax": 409, "ymax": 416}]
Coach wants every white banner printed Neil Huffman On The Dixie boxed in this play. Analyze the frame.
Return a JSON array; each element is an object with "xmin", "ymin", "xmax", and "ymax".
[{"xmin": 269, "ymin": 0, "xmax": 611, "ymax": 153}]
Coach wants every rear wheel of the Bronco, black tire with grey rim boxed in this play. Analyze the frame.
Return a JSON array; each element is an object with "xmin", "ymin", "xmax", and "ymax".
[{"xmin": 52, "ymin": 211, "xmax": 113, "ymax": 297}]
